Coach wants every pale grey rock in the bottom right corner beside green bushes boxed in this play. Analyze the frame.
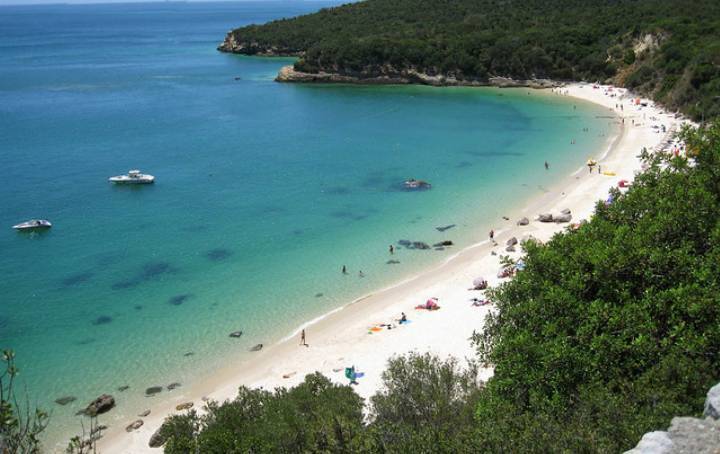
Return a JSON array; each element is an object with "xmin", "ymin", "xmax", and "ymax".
[{"xmin": 625, "ymin": 383, "xmax": 720, "ymax": 454}]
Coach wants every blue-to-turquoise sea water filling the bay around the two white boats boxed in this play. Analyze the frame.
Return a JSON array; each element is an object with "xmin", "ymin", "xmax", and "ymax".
[{"xmin": 0, "ymin": 2, "xmax": 613, "ymax": 446}]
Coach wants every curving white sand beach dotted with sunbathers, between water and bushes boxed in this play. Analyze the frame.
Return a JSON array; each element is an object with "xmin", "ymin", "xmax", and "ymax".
[{"xmin": 93, "ymin": 84, "xmax": 680, "ymax": 454}]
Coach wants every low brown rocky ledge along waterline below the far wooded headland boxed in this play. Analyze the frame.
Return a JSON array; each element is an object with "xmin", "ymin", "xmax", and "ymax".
[{"xmin": 275, "ymin": 65, "xmax": 561, "ymax": 88}]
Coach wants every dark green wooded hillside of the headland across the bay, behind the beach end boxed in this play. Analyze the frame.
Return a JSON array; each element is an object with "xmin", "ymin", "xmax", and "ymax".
[{"xmin": 224, "ymin": 0, "xmax": 720, "ymax": 119}]
